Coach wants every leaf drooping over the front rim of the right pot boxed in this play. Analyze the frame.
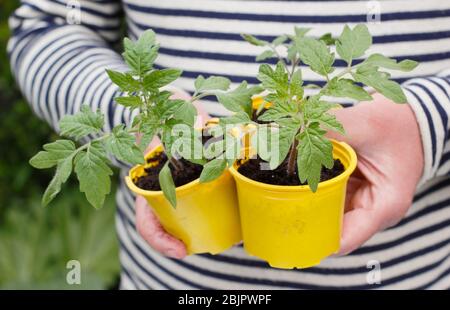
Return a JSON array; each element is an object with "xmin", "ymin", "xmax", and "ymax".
[{"xmin": 297, "ymin": 123, "xmax": 334, "ymax": 192}]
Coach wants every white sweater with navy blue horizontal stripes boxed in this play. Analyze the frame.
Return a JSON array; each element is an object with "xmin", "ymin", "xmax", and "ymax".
[{"xmin": 8, "ymin": 0, "xmax": 450, "ymax": 289}]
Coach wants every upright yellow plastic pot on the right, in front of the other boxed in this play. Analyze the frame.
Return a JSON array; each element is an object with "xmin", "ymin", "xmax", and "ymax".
[{"xmin": 230, "ymin": 141, "xmax": 357, "ymax": 269}]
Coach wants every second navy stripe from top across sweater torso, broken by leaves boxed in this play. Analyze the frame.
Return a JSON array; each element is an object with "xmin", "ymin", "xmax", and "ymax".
[{"xmin": 132, "ymin": 20, "xmax": 450, "ymax": 44}]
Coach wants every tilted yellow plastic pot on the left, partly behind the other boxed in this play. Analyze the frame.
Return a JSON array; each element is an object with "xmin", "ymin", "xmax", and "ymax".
[{"xmin": 126, "ymin": 146, "xmax": 242, "ymax": 254}]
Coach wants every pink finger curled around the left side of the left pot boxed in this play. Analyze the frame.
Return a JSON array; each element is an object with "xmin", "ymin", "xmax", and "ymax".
[{"xmin": 136, "ymin": 196, "xmax": 186, "ymax": 258}]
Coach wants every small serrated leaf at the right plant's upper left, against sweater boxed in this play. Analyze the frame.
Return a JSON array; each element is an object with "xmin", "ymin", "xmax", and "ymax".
[{"xmin": 257, "ymin": 62, "xmax": 289, "ymax": 94}]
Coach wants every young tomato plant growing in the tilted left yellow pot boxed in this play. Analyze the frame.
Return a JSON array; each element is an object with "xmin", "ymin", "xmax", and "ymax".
[{"xmin": 30, "ymin": 30, "xmax": 258, "ymax": 208}]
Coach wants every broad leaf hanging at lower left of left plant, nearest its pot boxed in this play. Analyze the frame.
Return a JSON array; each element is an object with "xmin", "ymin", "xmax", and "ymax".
[{"xmin": 75, "ymin": 145, "xmax": 113, "ymax": 209}]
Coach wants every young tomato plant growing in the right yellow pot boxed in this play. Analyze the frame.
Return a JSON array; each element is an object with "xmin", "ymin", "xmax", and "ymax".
[{"xmin": 237, "ymin": 25, "xmax": 417, "ymax": 192}]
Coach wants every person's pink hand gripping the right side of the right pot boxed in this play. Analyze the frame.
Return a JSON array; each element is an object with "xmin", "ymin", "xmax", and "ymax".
[{"xmin": 328, "ymin": 94, "xmax": 424, "ymax": 255}]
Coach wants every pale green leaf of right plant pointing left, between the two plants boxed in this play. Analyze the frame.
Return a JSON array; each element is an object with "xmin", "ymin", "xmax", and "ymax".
[{"xmin": 216, "ymin": 81, "xmax": 262, "ymax": 115}]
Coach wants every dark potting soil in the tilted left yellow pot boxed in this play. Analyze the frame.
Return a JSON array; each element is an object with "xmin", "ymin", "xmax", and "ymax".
[{"xmin": 134, "ymin": 153, "xmax": 203, "ymax": 191}]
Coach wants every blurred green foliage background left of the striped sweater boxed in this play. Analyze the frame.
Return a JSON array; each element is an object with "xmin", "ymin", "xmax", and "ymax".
[{"xmin": 0, "ymin": 0, "xmax": 119, "ymax": 289}]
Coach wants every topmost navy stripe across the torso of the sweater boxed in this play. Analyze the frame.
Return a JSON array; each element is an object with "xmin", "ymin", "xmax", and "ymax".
[{"xmin": 125, "ymin": 3, "xmax": 450, "ymax": 24}]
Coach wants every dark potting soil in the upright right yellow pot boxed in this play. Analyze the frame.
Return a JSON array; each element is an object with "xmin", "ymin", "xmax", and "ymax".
[{"xmin": 238, "ymin": 157, "xmax": 345, "ymax": 185}]
